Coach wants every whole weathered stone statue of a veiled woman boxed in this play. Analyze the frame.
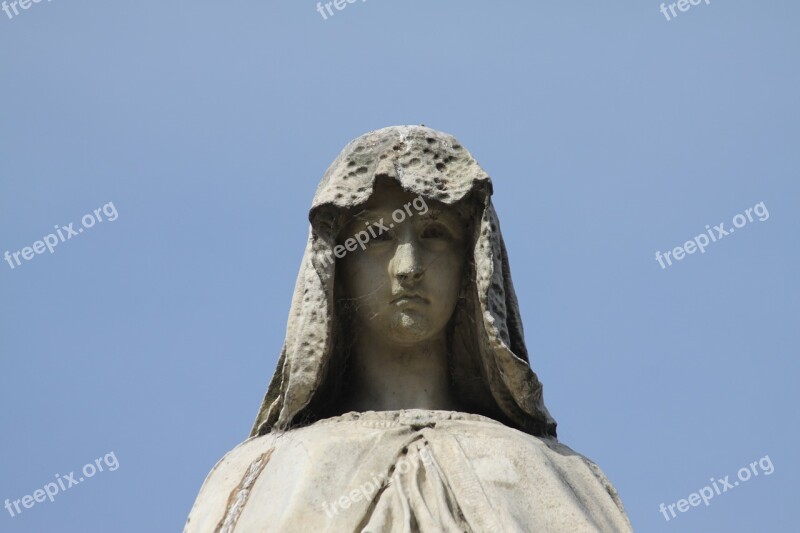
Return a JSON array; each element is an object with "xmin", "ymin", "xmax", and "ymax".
[{"xmin": 184, "ymin": 126, "xmax": 632, "ymax": 533}]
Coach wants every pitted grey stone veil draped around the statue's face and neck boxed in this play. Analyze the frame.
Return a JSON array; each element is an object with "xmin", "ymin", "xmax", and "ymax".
[{"xmin": 251, "ymin": 126, "xmax": 556, "ymax": 438}]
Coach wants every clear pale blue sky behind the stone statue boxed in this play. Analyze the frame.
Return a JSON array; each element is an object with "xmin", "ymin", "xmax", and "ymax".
[{"xmin": 0, "ymin": 0, "xmax": 800, "ymax": 533}]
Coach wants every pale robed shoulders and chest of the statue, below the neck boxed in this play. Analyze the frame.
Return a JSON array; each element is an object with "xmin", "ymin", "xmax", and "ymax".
[{"xmin": 186, "ymin": 411, "xmax": 630, "ymax": 533}]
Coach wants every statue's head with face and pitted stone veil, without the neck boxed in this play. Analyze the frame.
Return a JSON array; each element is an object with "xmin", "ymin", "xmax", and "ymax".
[{"xmin": 253, "ymin": 126, "xmax": 556, "ymax": 437}]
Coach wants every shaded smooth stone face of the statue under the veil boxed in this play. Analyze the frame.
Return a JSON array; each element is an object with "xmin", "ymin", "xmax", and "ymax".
[{"xmin": 337, "ymin": 182, "xmax": 465, "ymax": 344}]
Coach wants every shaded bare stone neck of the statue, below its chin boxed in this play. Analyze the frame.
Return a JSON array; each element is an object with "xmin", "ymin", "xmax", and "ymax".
[{"xmin": 345, "ymin": 330, "xmax": 458, "ymax": 412}]
